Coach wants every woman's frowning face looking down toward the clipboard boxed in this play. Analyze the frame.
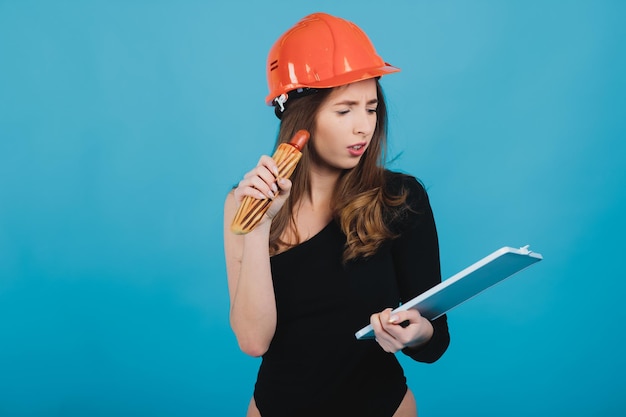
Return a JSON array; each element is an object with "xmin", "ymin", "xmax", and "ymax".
[{"xmin": 312, "ymin": 79, "xmax": 378, "ymax": 170}]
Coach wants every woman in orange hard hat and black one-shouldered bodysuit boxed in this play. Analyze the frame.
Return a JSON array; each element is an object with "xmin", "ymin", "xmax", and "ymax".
[{"xmin": 224, "ymin": 13, "xmax": 449, "ymax": 417}]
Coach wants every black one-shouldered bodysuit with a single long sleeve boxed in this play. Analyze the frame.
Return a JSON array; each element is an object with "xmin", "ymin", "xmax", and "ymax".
[{"xmin": 254, "ymin": 173, "xmax": 450, "ymax": 417}]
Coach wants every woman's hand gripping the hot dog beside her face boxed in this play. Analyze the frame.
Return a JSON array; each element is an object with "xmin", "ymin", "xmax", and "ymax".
[{"xmin": 235, "ymin": 155, "xmax": 291, "ymax": 220}]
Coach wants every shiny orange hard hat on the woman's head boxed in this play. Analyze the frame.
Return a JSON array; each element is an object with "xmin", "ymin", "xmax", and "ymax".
[{"xmin": 265, "ymin": 13, "xmax": 400, "ymax": 107}]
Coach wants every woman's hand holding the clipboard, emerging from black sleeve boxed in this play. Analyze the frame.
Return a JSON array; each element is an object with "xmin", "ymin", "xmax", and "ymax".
[{"xmin": 370, "ymin": 308, "xmax": 433, "ymax": 353}]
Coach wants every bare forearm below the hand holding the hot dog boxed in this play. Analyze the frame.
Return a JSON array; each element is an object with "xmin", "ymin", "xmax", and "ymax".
[{"xmin": 230, "ymin": 222, "xmax": 276, "ymax": 356}]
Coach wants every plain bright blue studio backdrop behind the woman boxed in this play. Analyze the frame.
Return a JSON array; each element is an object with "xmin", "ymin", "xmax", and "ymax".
[{"xmin": 0, "ymin": 0, "xmax": 626, "ymax": 417}]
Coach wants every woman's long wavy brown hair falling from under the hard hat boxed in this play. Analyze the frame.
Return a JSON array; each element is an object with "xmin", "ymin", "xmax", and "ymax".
[{"xmin": 270, "ymin": 80, "xmax": 406, "ymax": 262}]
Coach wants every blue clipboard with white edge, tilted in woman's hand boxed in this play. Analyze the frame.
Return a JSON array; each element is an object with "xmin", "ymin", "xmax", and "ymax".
[{"xmin": 355, "ymin": 246, "xmax": 543, "ymax": 340}]
